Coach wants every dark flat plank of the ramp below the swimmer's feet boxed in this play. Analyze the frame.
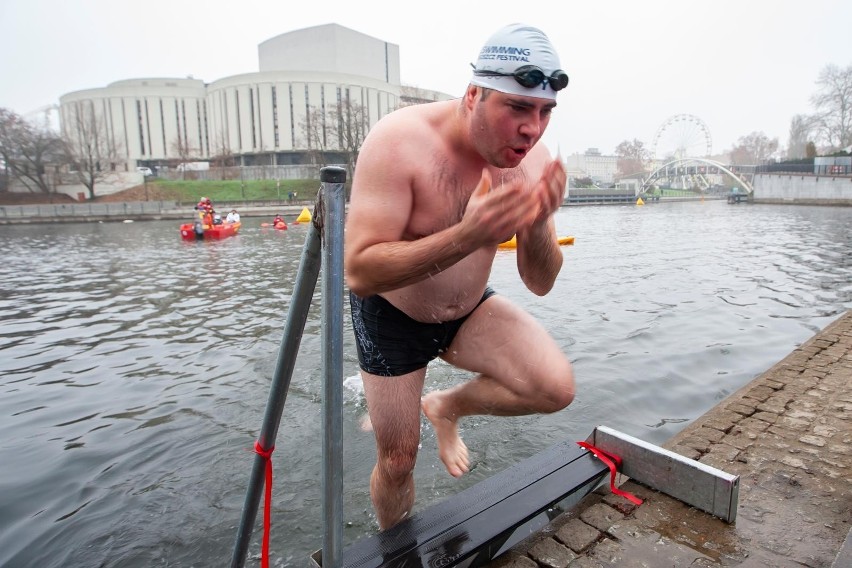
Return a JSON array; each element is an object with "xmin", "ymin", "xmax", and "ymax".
[{"xmin": 311, "ymin": 442, "xmax": 609, "ymax": 568}]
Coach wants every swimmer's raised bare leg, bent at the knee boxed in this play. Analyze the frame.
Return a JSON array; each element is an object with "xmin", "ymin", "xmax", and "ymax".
[{"xmin": 422, "ymin": 296, "xmax": 574, "ymax": 477}]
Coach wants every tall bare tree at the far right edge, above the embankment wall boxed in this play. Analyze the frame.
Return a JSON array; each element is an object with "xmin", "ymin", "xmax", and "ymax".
[{"xmin": 811, "ymin": 64, "xmax": 852, "ymax": 150}]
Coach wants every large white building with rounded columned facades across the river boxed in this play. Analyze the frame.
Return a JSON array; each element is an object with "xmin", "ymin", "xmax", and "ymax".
[{"xmin": 60, "ymin": 24, "xmax": 453, "ymax": 171}]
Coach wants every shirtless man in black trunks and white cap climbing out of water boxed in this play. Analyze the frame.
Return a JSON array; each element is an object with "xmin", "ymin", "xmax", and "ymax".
[{"xmin": 345, "ymin": 24, "xmax": 574, "ymax": 529}]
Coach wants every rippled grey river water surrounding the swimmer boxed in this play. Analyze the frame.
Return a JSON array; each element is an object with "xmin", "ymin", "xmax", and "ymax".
[{"xmin": 0, "ymin": 201, "xmax": 852, "ymax": 568}]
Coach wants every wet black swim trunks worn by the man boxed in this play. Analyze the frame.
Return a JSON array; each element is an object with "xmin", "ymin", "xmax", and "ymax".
[{"xmin": 349, "ymin": 287, "xmax": 496, "ymax": 377}]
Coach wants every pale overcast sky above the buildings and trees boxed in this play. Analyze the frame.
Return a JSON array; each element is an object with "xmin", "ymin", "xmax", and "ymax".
[{"xmin": 0, "ymin": 0, "xmax": 852, "ymax": 155}]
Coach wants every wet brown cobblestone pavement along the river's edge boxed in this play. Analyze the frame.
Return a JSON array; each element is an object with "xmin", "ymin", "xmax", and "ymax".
[{"xmin": 489, "ymin": 311, "xmax": 852, "ymax": 568}]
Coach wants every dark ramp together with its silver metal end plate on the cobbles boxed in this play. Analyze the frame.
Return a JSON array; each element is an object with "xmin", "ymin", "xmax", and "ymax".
[{"xmin": 311, "ymin": 426, "xmax": 739, "ymax": 568}]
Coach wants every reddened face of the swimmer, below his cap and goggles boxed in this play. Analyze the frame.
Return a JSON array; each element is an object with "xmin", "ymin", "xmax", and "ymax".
[{"xmin": 471, "ymin": 87, "xmax": 556, "ymax": 168}]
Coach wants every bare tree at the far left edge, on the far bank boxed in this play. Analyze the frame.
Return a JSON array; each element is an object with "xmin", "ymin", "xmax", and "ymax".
[{"xmin": 0, "ymin": 108, "xmax": 61, "ymax": 193}]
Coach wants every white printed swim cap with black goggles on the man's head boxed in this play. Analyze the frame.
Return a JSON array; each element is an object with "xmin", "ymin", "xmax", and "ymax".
[{"xmin": 470, "ymin": 24, "xmax": 568, "ymax": 100}]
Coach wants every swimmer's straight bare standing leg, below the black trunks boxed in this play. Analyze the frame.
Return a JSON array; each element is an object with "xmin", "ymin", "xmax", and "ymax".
[{"xmin": 361, "ymin": 368, "xmax": 426, "ymax": 530}]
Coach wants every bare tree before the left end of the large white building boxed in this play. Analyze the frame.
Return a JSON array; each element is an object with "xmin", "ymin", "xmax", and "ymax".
[{"xmin": 63, "ymin": 102, "xmax": 124, "ymax": 199}]
